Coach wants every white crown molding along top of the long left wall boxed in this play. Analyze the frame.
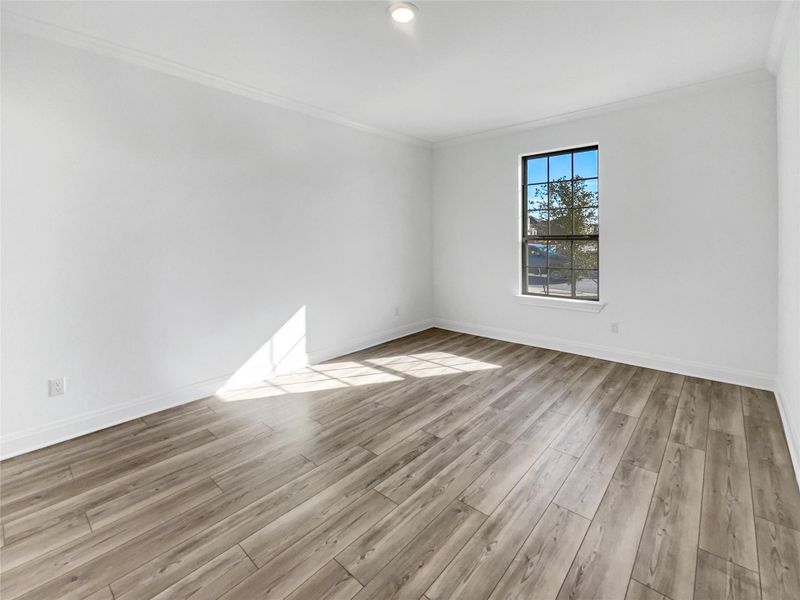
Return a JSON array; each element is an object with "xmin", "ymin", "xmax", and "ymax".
[{"xmin": 2, "ymin": 8, "xmax": 432, "ymax": 148}]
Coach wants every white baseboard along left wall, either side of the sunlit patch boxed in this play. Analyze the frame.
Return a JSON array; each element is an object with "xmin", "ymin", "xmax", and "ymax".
[{"xmin": 0, "ymin": 319, "xmax": 433, "ymax": 459}]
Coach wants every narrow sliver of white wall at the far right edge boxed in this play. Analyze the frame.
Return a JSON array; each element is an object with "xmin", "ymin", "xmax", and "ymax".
[{"xmin": 776, "ymin": 7, "xmax": 800, "ymax": 474}]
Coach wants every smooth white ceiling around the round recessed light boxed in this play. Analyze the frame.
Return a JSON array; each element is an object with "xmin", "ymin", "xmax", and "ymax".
[{"xmin": 3, "ymin": 0, "xmax": 778, "ymax": 142}]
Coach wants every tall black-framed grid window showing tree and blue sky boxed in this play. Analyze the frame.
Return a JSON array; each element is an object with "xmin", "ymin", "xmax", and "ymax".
[{"xmin": 522, "ymin": 146, "xmax": 600, "ymax": 300}]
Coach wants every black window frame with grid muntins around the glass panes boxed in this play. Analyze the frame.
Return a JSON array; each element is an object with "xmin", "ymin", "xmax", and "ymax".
[{"xmin": 520, "ymin": 144, "xmax": 600, "ymax": 302}]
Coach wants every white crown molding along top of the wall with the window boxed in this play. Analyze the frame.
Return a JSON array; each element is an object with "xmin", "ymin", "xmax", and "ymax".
[{"xmin": 433, "ymin": 69, "xmax": 774, "ymax": 150}]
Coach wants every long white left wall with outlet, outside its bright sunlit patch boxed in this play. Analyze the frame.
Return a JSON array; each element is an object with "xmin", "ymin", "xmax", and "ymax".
[{"xmin": 2, "ymin": 32, "xmax": 432, "ymax": 456}]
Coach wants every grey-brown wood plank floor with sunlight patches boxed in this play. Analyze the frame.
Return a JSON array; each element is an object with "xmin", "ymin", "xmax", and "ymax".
[{"xmin": 0, "ymin": 329, "xmax": 800, "ymax": 600}]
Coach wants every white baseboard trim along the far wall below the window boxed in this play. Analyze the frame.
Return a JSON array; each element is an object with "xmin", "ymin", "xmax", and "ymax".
[{"xmin": 435, "ymin": 319, "xmax": 775, "ymax": 390}]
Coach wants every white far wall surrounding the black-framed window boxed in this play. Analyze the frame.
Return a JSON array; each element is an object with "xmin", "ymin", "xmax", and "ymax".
[{"xmin": 433, "ymin": 72, "xmax": 777, "ymax": 387}]
